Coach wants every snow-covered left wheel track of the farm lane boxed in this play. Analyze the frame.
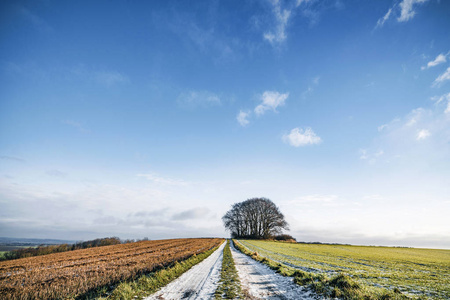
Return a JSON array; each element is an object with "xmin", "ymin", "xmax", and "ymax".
[{"xmin": 145, "ymin": 242, "xmax": 226, "ymax": 300}]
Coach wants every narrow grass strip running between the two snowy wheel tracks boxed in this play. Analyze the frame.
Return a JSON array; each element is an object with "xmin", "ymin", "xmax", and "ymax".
[{"xmin": 215, "ymin": 240, "xmax": 243, "ymax": 299}]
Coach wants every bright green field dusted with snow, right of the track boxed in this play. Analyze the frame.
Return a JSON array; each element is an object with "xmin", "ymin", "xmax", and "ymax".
[{"xmin": 240, "ymin": 240, "xmax": 450, "ymax": 299}]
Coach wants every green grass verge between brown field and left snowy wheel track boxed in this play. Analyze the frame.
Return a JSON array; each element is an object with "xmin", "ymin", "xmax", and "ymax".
[{"xmin": 88, "ymin": 241, "xmax": 220, "ymax": 300}]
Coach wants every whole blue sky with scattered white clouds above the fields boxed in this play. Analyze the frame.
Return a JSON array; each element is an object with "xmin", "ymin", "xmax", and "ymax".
[{"xmin": 0, "ymin": 0, "xmax": 450, "ymax": 248}]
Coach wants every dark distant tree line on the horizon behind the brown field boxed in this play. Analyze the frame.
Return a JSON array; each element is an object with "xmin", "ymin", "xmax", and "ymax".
[{"xmin": 0, "ymin": 237, "xmax": 121, "ymax": 260}]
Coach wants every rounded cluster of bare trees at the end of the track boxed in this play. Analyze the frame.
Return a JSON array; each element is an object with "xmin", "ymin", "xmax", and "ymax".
[{"xmin": 222, "ymin": 198, "xmax": 289, "ymax": 239}]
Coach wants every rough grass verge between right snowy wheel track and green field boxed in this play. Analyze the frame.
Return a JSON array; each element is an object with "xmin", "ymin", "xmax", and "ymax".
[{"xmin": 233, "ymin": 240, "xmax": 421, "ymax": 300}]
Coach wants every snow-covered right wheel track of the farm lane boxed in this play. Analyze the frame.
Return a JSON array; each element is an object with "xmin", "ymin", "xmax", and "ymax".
[{"xmin": 230, "ymin": 243, "xmax": 314, "ymax": 300}]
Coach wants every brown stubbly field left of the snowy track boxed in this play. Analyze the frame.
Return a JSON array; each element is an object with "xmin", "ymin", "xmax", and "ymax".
[{"xmin": 0, "ymin": 239, "xmax": 223, "ymax": 299}]
